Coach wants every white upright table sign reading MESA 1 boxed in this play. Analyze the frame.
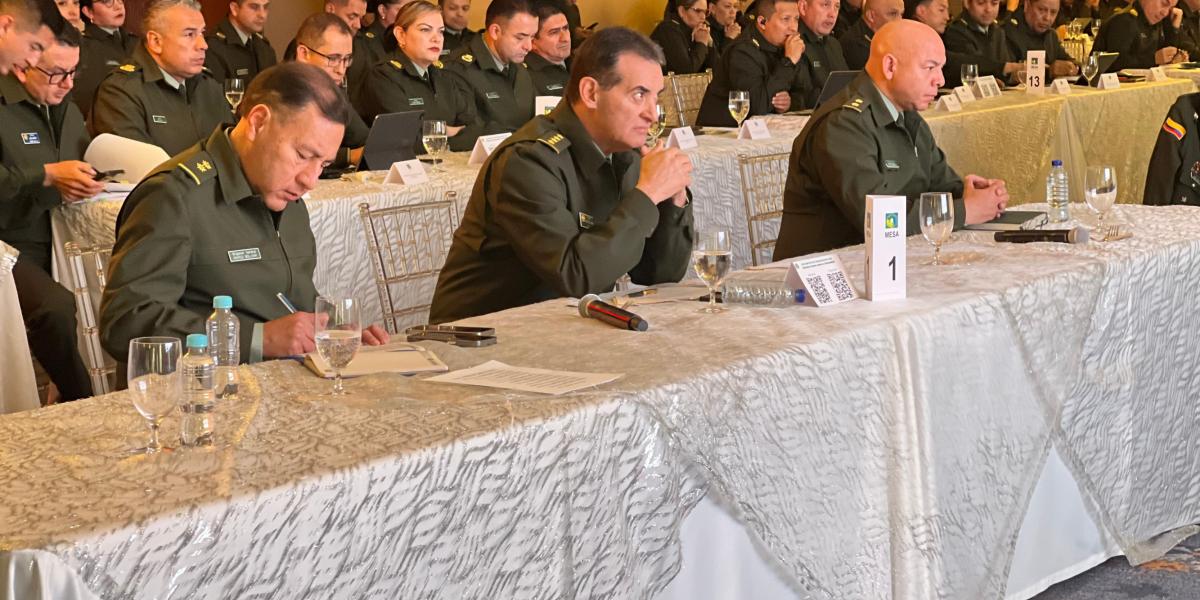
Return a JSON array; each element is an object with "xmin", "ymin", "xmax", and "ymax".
[{"xmin": 863, "ymin": 196, "xmax": 908, "ymax": 301}]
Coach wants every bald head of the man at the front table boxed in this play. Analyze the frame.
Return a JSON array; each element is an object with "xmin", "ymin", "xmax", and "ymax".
[{"xmin": 866, "ymin": 19, "xmax": 946, "ymax": 110}]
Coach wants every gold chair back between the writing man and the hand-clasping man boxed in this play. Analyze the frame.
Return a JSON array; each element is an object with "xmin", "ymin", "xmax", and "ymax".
[{"xmin": 359, "ymin": 192, "xmax": 458, "ymax": 334}]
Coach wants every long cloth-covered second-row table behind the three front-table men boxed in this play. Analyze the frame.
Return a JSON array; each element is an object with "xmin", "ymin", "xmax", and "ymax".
[{"xmin": 55, "ymin": 79, "xmax": 1195, "ymax": 328}]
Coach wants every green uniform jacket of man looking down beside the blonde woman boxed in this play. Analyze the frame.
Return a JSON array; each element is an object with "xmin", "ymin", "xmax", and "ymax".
[{"xmin": 445, "ymin": 36, "xmax": 534, "ymax": 136}]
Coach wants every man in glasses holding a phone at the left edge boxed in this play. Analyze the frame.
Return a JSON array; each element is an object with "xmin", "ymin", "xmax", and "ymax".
[{"xmin": 0, "ymin": 26, "xmax": 103, "ymax": 400}]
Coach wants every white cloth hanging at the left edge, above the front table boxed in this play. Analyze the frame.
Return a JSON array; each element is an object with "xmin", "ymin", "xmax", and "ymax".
[{"xmin": 0, "ymin": 241, "xmax": 42, "ymax": 414}]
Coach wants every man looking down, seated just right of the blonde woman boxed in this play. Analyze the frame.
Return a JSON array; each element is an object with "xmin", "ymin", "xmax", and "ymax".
[{"xmin": 444, "ymin": 0, "xmax": 538, "ymax": 134}]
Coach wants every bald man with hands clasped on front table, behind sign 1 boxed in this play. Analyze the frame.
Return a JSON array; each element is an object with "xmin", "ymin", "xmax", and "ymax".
[{"xmin": 775, "ymin": 20, "xmax": 1008, "ymax": 260}]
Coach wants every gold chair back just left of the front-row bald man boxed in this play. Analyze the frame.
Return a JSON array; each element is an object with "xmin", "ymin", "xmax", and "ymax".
[{"xmin": 738, "ymin": 152, "xmax": 791, "ymax": 265}]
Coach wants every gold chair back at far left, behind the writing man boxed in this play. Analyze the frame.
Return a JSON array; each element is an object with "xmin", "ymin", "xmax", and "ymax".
[{"xmin": 62, "ymin": 241, "xmax": 116, "ymax": 396}]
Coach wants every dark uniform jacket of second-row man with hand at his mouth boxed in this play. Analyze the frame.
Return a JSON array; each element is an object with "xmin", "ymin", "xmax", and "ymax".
[{"xmin": 696, "ymin": 29, "xmax": 811, "ymax": 127}]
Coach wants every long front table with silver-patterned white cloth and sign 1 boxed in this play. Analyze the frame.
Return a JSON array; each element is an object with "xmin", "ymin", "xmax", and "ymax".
[{"xmin": 0, "ymin": 206, "xmax": 1200, "ymax": 600}]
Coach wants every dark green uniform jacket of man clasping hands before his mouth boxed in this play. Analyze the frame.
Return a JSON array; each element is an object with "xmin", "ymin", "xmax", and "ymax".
[{"xmin": 430, "ymin": 102, "xmax": 692, "ymax": 323}]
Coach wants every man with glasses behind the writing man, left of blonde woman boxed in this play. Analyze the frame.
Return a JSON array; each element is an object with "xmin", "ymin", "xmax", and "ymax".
[{"xmin": 290, "ymin": 12, "xmax": 371, "ymax": 171}]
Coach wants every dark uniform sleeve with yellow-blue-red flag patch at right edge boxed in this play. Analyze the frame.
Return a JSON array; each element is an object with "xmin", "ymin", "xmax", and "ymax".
[{"xmin": 1142, "ymin": 94, "xmax": 1200, "ymax": 206}]
